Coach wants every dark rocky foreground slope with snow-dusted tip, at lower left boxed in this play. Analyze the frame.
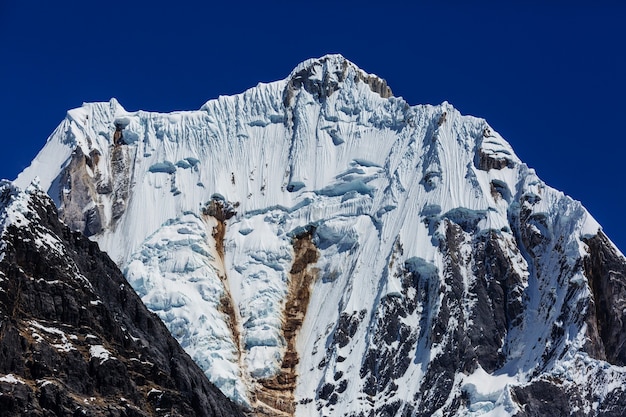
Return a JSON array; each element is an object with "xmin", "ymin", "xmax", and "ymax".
[{"xmin": 0, "ymin": 182, "xmax": 243, "ymax": 417}]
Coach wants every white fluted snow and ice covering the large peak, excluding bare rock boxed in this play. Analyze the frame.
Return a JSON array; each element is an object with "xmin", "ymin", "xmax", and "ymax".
[{"xmin": 17, "ymin": 56, "xmax": 623, "ymax": 416}]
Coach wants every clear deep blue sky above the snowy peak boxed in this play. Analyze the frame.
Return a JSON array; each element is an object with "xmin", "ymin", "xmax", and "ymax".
[{"xmin": 0, "ymin": 0, "xmax": 626, "ymax": 251}]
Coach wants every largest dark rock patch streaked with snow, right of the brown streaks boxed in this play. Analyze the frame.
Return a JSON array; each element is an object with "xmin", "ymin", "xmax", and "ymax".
[{"xmin": 348, "ymin": 223, "xmax": 524, "ymax": 416}]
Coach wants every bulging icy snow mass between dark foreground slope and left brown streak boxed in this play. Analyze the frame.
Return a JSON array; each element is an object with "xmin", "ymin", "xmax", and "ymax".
[{"xmin": 124, "ymin": 213, "xmax": 246, "ymax": 401}]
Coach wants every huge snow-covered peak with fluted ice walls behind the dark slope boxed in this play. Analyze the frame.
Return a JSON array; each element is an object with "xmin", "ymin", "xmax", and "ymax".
[{"xmin": 16, "ymin": 55, "xmax": 626, "ymax": 416}]
